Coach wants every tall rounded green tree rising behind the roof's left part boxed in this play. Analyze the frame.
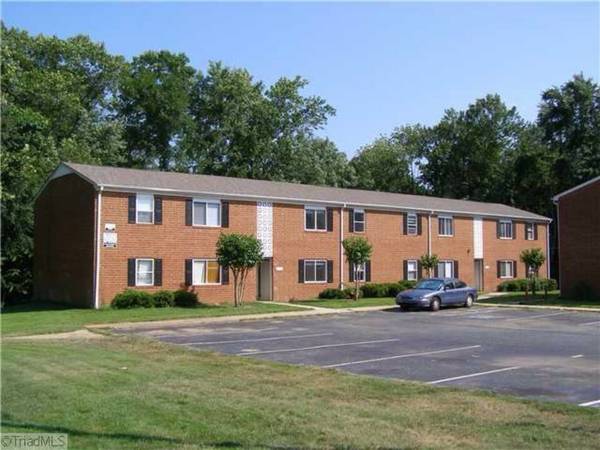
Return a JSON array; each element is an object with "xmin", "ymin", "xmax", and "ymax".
[{"xmin": 119, "ymin": 50, "xmax": 195, "ymax": 170}]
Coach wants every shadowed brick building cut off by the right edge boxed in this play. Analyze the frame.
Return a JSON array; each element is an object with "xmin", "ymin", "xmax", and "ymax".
[{"xmin": 553, "ymin": 177, "xmax": 600, "ymax": 297}]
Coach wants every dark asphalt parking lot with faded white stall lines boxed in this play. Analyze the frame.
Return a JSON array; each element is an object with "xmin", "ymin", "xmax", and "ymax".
[{"xmin": 114, "ymin": 307, "xmax": 600, "ymax": 407}]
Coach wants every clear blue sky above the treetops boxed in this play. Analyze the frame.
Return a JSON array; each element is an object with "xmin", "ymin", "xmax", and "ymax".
[{"xmin": 2, "ymin": 2, "xmax": 600, "ymax": 156}]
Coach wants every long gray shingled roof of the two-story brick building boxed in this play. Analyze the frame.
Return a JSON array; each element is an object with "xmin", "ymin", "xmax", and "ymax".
[{"xmin": 63, "ymin": 163, "xmax": 550, "ymax": 221}]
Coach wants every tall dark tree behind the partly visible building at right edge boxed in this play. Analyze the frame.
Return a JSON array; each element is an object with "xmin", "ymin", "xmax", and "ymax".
[{"xmin": 537, "ymin": 75, "xmax": 600, "ymax": 193}]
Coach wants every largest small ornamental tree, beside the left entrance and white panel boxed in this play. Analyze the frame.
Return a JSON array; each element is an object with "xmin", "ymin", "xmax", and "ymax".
[{"xmin": 217, "ymin": 233, "xmax": 263, "ymax": 306}]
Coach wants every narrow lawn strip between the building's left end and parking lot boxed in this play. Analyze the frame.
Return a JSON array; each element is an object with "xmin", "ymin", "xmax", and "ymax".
[{"xmin": 0, "ymin": 303, "xmax": 298, "ymax": 336}]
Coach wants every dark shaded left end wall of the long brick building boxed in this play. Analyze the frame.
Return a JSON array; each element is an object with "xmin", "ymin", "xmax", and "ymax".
[{"xmin": 33, "ymin": 175, "xmax": 96, "ymax": 307}]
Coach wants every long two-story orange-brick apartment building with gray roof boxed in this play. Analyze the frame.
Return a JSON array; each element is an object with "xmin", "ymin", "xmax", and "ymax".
[{"xmin": 34, "ymin": 163, "xmax": 550, "ymax": 307}]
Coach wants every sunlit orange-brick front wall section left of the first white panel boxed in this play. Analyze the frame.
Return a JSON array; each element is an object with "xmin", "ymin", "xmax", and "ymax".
[{"xmin": 100, "ymin": 192, "xmax": 256, "ymax": 304}]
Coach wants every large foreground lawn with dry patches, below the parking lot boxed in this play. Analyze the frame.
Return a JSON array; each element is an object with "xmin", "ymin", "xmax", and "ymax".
[{"xmin": 1, "ymin": 337, "xmax": 600, "ymax": 449}]
